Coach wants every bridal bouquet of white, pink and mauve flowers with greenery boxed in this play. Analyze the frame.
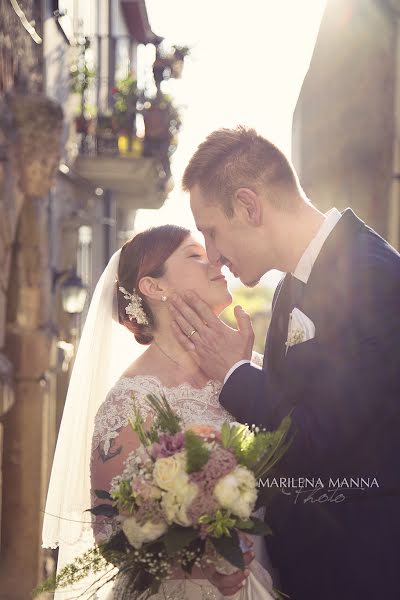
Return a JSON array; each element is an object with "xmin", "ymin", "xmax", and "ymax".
[{"xmin": 34, "ymin": 395, "xmax": 291, "ymax": 600}]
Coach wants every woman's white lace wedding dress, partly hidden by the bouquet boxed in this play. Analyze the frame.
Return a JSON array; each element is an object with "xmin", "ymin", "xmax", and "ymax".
[{"xmin": 92, "ymin": 355, "xmax": 275, "ymax": 600}]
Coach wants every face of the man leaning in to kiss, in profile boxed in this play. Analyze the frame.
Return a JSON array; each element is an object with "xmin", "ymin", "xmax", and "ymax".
[{"xmin": 190, "ymin": 185, "xmax": 264, "ymax": 287}]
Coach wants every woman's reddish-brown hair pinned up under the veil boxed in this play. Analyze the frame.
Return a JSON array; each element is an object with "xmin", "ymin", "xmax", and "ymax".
[{"xmin": 116, "ymin": 225, "xmax": 190, "ymax": 344}]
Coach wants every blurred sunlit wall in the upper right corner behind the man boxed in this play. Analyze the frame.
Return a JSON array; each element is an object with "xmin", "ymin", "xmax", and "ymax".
[{"xmin": 293, "ymin": 0, "xmax": 396, "ymax": 235}]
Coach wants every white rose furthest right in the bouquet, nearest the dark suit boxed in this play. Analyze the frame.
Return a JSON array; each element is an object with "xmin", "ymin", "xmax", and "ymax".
[{"xmin": 214, "ymin": 466, "xmax": 257, "ymax": 519}]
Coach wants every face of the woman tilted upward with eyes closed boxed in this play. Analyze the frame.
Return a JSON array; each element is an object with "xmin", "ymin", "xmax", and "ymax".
[{"xmin": 162, "ymin": 235, "xmax": 232, "ymax": 315}]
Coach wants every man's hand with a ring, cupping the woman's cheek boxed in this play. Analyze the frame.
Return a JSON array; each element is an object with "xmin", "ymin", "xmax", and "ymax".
[{"xmin": 169, "ymin": 292, "xmax": 254, "ymax": 381}]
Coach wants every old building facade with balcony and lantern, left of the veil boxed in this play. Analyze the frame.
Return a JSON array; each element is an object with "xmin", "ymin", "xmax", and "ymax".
[{"xmin": 0, "ymin": 0, "xmax": 183, "ymax": 600}]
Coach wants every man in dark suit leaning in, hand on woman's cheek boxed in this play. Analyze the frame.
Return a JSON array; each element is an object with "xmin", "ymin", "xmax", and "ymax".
[{"xmin": 170, "ymin": 127, "xmax": 400, "ymax": 600}]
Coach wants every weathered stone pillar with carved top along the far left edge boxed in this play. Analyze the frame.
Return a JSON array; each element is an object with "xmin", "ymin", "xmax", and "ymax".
[{"xmin": 0, "ymin": 92, "xmax": 63, "ymax": 600}]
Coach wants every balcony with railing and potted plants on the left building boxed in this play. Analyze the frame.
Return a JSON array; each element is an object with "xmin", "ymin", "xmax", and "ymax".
[{"xmin": 74, "ymin": 75, "xmax": 180, "ymax": 210}]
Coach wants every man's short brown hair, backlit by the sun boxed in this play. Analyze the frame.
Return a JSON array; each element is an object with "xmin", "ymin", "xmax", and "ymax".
[{"xmin": 182, "ymin": 126, "xmax": 301, "ymax": 215}]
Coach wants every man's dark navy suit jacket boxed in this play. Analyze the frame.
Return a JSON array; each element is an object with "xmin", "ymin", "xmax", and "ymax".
[{"xmin": 220, "ymin": 209, "xmax": 400, "ymax": 600}]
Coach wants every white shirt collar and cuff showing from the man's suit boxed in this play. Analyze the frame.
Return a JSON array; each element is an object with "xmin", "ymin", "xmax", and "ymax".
[{"xmin": 224, "ymin": 208, "xmax": 342, "ymax": 384}]
